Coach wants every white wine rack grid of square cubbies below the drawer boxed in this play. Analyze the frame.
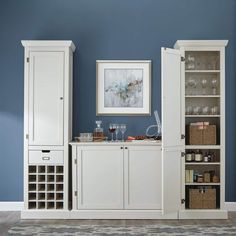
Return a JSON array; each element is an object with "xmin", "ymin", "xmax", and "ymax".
[{"xmin": 28, "ymin": 165, "xmax": 64, "ymax": 210}]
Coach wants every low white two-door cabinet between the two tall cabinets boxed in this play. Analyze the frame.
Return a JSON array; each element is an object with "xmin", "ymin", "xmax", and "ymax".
[{"xmin": 72, "ymin": 143, "xmax": 162, "ymax": 210}]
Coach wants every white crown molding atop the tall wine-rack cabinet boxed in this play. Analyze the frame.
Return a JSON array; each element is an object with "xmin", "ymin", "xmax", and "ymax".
[{"xmin": 21, "ymin": 40, "xmax": 76, "ymax": 52}]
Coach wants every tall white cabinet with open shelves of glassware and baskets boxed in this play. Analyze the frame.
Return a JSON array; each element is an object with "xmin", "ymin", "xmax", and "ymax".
[{"xmin": 175, "ymin": 40, "xmax": 228, "ymax": 219}]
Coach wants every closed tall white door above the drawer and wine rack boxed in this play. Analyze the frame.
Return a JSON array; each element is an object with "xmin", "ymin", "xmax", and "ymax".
[{"xmin": 29, "ymin": 52, "xmax": 64, "ymax": 145}]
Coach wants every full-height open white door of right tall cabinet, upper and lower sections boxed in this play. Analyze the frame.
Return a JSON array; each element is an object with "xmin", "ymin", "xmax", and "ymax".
[{"xmin": 161, "ymin": 48, "xmax": 184, "ymax": 214}]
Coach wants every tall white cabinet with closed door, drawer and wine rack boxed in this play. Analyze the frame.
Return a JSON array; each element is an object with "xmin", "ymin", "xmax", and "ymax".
[{"xmin": 22, "ymin": 41, "xmax": 75, "ymax": 216}]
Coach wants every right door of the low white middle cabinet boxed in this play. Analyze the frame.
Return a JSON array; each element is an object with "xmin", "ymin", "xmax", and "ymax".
[{"xmin": 124, "ymin": 146, "xmax": 162, "ymax": 209}]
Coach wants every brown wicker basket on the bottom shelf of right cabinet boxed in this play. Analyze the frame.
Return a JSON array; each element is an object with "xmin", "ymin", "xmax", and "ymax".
[{"xmin": 189, "ymin": 189, "xmax": 216, "ymax": 209}]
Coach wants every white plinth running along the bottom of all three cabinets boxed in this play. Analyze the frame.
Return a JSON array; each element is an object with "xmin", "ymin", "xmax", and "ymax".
[{"xmin": 21, "ymin": 210, "xmax": 228, "ymax": 220}]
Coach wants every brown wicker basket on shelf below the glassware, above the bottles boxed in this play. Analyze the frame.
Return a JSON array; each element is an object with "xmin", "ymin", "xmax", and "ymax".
[{"xmin": 189, "ymin": 125, "xmax": 216, "ymax": 145}]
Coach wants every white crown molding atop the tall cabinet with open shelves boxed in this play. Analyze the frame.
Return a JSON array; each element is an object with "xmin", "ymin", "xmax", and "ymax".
[{"xmin": 174, "ymin": 40, "xmax": 228, "ymax": 49}]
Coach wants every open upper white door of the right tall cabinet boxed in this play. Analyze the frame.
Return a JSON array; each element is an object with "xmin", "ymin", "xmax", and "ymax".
[{"xmin": 161, "ymin": 48, "xmax": 184, "ymax": 148}]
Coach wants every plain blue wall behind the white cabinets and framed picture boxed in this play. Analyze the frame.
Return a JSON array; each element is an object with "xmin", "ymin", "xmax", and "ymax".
[{"xmin": 0, "ymin": 0, "xmax": 236, "ymax": 201}]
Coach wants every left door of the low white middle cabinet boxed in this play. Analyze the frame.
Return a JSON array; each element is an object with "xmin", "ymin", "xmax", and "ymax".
[{"xmin": 77, "ymin": 146, "xmax": 124, "ymax": 209}]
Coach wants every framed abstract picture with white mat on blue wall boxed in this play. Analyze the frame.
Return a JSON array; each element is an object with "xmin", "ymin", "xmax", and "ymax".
[{"xmin": 96, "ymin": 60, "xmax": 151, "ymax": 115}]
